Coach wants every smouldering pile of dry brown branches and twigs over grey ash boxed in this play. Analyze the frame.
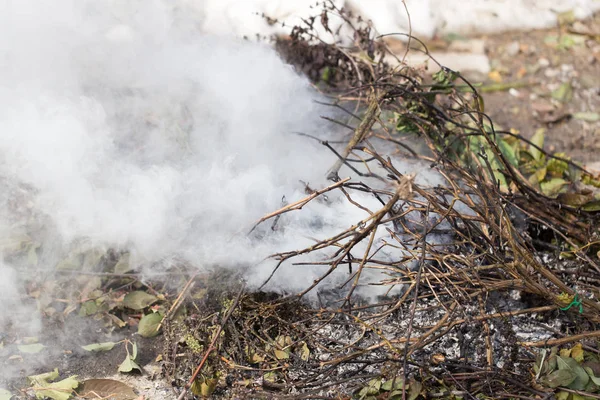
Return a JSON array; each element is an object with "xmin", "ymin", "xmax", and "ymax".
[{"xmin": 166, "ymin": 6, "xmax": 600, "ymax": 399}]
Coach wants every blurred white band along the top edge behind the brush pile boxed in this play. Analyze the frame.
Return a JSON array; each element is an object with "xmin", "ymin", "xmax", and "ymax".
[{"xmin": 195, "ymin": 0, "xmax": 600, "ymax": 37}]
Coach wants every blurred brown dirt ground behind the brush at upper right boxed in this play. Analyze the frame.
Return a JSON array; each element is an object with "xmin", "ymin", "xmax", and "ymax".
[{"xmin": 483, "ymin": 15, "xmax": 600, "ymax": 169}]
